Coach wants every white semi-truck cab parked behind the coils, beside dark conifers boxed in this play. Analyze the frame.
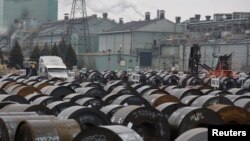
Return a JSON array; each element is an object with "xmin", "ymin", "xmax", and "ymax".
[{"xmin": 38, "ymin": 56, "xmax": 68, "ymax": 79}]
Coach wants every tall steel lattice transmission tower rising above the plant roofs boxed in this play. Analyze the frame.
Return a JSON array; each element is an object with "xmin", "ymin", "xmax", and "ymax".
[{"xmin": 67, "ymin": 0, "xmax": 91, "ymax": 52}]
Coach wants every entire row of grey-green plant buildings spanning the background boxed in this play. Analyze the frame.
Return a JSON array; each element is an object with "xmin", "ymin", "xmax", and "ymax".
[{"xmin": 0, "ymin": 0, "xmax": 250, "ymax": 71}]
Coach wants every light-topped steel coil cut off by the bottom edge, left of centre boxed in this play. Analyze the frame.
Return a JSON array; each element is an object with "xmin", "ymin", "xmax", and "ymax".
[{"xmin": 73, "ymin": 125, "xmax": 143, "ymax": 141}]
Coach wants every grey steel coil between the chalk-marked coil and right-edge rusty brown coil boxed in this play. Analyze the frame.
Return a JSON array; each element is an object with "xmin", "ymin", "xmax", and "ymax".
[{"xmin": 191, "ymin": 95, "xmax": 234, "ymax": 108}]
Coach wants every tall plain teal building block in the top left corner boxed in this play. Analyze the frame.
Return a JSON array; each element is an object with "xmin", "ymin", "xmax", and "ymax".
[{"xmin": 0, "ymin": 0, "xmax": 58, "ymax": 32}]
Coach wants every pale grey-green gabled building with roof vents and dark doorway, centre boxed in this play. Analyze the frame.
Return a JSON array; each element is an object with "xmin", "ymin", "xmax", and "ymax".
[{"xmin": 99, "ymin": 10, "xmax": 184, "ymax": 67}]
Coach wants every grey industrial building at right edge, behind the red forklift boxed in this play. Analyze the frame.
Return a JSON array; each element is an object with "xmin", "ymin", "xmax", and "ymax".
[{"xmin": 159, "ymin": 12, "xmax": 250, "ymax": 71}]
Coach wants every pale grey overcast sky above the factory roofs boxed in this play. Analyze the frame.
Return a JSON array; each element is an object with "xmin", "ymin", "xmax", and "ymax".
[{"xmin": 58, "ymin": 0, "xmax": 250, "ymax": 22}]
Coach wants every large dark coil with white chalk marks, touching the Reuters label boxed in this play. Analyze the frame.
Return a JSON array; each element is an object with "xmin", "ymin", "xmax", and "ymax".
[{"xmin": 168, "ymin": 107, "xmax": 223, "ymax": 139}]
